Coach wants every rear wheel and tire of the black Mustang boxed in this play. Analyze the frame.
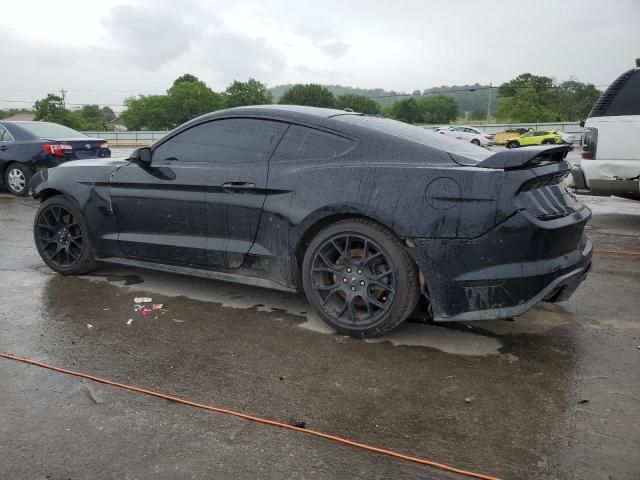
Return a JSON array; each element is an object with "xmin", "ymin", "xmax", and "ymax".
[{"xmin": 302, "ymin": 219, "xmax": 420, "ymax": 338}]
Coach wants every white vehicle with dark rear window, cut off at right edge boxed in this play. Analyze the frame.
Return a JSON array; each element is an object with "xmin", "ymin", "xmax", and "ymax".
[{"xmin": 571, "ymin": 59, "xmax": 640, "ymax": 198}]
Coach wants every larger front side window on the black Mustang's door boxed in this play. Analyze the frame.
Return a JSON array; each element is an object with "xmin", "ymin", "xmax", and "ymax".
[{"xmin": 153, "ymin": 118, "xmax": 287, "ymax": 163}]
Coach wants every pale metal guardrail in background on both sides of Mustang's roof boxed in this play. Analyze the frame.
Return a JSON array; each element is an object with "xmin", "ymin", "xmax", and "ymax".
[{"xmin": 83, "ymin": 122, "xmax": 583, "ymax": 146}]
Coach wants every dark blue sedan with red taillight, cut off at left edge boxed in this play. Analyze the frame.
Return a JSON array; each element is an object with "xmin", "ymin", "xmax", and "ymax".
[{"xmin": 0, "ymin": 120, "xmax": 111, "ymax": 196}]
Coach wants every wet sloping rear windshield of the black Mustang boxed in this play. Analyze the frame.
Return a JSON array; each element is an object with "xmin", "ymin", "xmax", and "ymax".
[{"xmin": 333, "ymin": 115, "xmax": 493, "ymax": 162}]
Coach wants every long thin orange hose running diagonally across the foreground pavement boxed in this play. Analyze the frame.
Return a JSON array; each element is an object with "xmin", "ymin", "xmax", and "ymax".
[{"xmin": 0, "ymin": 352, "xmax": 499, "ymax": 480}]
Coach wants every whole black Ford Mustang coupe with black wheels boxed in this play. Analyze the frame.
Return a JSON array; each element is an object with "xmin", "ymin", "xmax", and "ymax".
[{"xmin": 31, "ymin": 106, "xmax": 591, "ymax": 336}]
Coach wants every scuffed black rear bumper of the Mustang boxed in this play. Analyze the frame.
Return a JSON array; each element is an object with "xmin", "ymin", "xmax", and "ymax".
[{"xmin": 409, "ymin": 208, "xmax": 592, "ymax": 321}]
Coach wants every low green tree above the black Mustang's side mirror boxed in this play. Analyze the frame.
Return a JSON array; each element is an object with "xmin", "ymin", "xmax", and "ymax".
[{"xmin": 121, "ymin": 95, "xmax": 173, "ymax": 130}]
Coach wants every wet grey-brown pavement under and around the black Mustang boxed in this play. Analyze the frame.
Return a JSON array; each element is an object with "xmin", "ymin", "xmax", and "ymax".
[{"xmin": 0, "ymin": 194, "xmax": 640, "ymax": 480}]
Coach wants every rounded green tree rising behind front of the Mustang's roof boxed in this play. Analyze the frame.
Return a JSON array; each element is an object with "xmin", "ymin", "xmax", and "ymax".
[{"xmin": 167, "ymin": 80, "xmax": 225, "ymax": 126}]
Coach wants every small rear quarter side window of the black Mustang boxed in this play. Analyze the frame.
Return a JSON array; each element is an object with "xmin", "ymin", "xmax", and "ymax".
[{"xmin": 275, "ymin": 125, "xmax": 353, "ymax": 160}]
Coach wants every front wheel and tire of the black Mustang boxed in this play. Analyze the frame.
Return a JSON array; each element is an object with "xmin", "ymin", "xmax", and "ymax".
[{"xmin": 33, "ymin": 195, "xmax": 98, "ymax": 275}]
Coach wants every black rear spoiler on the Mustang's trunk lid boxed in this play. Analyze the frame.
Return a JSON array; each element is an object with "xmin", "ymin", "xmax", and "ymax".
[{"xmin": 452, "ymin": 145, "xmax": 571, "ymax": 170}]
